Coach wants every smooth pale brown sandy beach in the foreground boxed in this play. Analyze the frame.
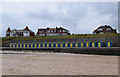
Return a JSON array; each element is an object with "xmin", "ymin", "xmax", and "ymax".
[{"xmin": 0, "ymin": 51, "xmax": 118, "ymax": 75}]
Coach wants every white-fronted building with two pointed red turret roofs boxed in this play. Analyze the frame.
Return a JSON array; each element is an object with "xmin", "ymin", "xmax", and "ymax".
[{"xmin": 6, "ymin": 26, "xmax": 35, "ymax": 37}]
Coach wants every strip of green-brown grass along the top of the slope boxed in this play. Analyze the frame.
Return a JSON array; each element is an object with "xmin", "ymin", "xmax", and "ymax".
[{"xmin": 0, "ymin": 33, "xmax": 120, "ymax": 44}]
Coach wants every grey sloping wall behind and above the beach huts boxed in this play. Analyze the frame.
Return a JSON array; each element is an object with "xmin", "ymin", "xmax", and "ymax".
[{"xmin": 3, "ymin": 36, "xmax": 120, "ymax": 47}]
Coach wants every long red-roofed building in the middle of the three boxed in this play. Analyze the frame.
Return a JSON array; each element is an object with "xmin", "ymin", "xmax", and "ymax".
[{"xmin": 36, "ymin": 27, "xmax": 70, "ymax": 36}]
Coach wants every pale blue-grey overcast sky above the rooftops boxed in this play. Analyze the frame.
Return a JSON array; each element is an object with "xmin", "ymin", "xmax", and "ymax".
[{"xmin": 2, "ymin": 2, "xmax": 118, "ymax": 36}]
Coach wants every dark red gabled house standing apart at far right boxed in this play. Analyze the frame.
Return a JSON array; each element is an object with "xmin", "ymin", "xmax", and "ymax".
[{"xmin": 93, "ymin": 25, "xmax": 117, "ymax": 34}]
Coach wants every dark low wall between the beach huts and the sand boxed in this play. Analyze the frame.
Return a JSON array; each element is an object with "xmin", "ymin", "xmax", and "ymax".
[{"xmin": 2, "ymin": 47, "xmax": 120, "ymax": 56}]
